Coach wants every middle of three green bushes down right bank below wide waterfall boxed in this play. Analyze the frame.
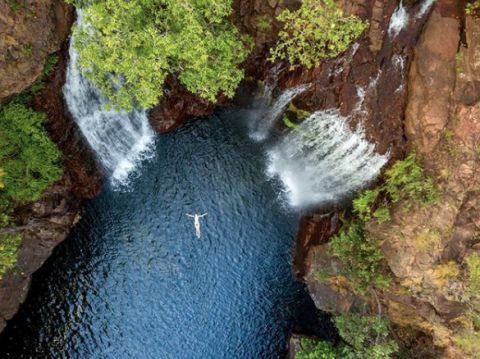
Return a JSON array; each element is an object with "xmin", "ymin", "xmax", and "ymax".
[{"xmin": 329, "ymin": 221, "xmax": 390, "ymax": 293}]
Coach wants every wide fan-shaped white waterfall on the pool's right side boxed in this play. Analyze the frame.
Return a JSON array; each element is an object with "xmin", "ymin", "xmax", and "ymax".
[{"xmin": 267, "ymin": 109, "xmax": 388, "ymax": 208}]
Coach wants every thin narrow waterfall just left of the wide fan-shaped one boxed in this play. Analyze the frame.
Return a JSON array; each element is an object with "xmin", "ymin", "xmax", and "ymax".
[{"xmin": 250, "ymin": 85, "xmax": 308, "ymax": 142}]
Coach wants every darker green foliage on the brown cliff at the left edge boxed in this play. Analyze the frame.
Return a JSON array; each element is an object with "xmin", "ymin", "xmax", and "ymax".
[{"xmin": 0, "ymin": 55, "xmax": 63, "ymax": 278}]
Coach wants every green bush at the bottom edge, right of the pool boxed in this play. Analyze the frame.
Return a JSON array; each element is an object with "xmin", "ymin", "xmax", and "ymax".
[{"xmin": 335, "ymin": 314, "xmax": 399, "ymax": 359}]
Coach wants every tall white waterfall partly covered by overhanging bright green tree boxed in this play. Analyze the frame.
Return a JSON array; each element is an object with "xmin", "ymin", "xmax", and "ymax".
[{"xmin": 63, "ymin": 11, "xmax": 155, "ymax": 187}]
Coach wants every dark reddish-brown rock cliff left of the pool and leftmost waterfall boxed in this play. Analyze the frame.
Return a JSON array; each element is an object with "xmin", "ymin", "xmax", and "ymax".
[{"xmin": 0, "ymin": 1, "xmax": 101, "ymax": 332}]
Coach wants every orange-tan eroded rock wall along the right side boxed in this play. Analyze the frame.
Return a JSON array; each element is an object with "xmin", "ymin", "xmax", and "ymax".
[{"xmin": 301, "ymin": 0, "xmax": 480, "ymax": 358}]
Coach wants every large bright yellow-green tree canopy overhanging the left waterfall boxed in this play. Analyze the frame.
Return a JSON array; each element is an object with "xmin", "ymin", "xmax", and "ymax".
[{"xmin": 70, "ymin": 0, "xmax": 250, "ymax": 110}]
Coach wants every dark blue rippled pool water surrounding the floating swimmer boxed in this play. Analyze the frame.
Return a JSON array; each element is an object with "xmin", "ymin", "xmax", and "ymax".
[{"xmin": 0, "ymin": 112, "xmax": 326, "ymax": 359}]
